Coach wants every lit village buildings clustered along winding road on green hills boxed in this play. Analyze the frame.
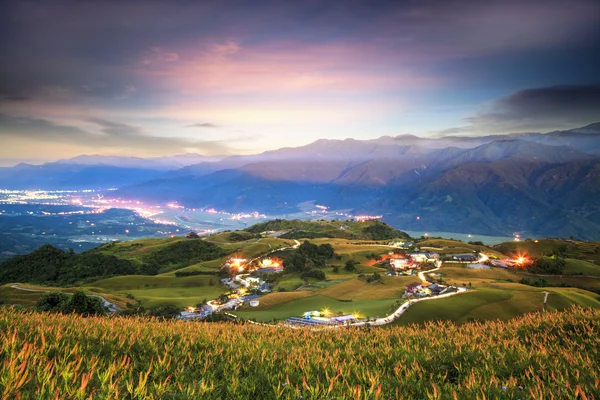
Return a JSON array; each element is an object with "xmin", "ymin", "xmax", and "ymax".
[{"xmin": 180, "ymin": 238, "xmax": 504, "ymax": 327}]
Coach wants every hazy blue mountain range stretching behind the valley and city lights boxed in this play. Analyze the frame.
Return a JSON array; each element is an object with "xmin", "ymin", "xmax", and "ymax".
[{"xmin": 0, "ymin": 123, "xmax": 600, "ymax": 239}]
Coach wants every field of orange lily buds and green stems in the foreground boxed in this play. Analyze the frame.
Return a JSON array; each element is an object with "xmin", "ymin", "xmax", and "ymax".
[{"xmin": 0, "ymin": 308, "xmax": 600, "ymax": 399}]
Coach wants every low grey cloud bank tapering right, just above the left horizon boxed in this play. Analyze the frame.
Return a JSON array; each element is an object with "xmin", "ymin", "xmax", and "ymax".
[{"xmin": 0, "ymin": 113, "xmax": 232, "ymax": 155}]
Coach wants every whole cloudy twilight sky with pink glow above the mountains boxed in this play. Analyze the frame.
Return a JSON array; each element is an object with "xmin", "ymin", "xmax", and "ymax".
[{"xmin": 0, "ymin": 0, "xmax": 600, "ymax": 165}]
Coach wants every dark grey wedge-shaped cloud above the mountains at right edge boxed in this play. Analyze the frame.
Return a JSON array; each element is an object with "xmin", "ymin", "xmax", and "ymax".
[{"xmin": 439, "ymin": 84, "xmax": 600, "ymax": 135}]
